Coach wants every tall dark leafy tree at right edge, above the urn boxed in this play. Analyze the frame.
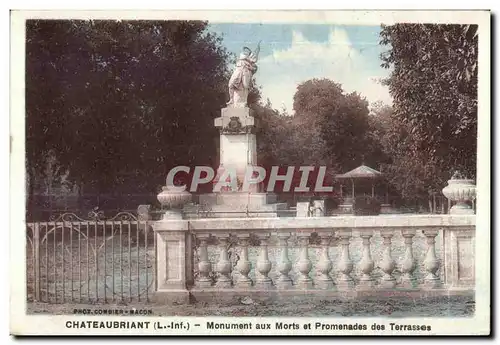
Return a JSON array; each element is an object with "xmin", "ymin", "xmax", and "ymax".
[{"xmin": 381, "ymin": 24, "xmax": 477, "ymax": 189}]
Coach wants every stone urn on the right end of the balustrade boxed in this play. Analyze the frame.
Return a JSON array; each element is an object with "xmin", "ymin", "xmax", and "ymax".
[{"xmin": 443, "ymin": 172, "xmax": 476, "ymax": 214}]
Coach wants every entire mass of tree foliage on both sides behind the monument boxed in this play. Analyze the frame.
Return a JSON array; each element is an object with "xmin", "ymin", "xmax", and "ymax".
[{"xmin": 26, "ymin": 20, "xmax": 477, "ymax": 218}]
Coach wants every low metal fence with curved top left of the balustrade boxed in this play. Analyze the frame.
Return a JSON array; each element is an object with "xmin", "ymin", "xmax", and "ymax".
[{"xmin": 26, "ymin": 212, "xmax": 156, "ymax": 304}]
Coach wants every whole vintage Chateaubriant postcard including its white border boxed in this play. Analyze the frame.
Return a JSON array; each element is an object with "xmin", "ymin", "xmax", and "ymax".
[{"xmin": 9, "ymin": 11, "xmax": 491, "ymax": 336}]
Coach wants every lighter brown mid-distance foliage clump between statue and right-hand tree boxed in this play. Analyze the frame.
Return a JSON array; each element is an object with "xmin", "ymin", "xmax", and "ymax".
[{"xmin": 257, "ymin": 79, "xmax": 386, "ymax": 202}]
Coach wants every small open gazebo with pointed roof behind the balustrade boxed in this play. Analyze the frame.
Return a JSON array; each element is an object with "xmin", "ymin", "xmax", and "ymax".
[{"xmin": 335, "ymin": 164, "xmax": 389, "ymax": 208}]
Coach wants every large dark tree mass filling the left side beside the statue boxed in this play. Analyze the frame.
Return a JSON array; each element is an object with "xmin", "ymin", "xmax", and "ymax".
[{"xmin": 26, "ymin": 20, "xmax": 229, "ymax": 215}]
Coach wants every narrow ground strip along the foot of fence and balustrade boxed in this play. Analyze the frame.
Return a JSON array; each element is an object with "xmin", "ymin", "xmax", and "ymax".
[{"xmin": 28, "ymin": 296, "xmax": 475, "ymax": 318}]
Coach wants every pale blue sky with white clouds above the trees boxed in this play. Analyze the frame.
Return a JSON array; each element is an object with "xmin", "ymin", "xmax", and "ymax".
[{"xmin": 209, "ymin": 23, "xmax": 392, "ymax": 113}]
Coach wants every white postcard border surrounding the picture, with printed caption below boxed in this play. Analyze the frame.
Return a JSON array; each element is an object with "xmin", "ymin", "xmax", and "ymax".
[{"xmin": 9, "ymin": 10, "xmax": 491, "ymax": 335}]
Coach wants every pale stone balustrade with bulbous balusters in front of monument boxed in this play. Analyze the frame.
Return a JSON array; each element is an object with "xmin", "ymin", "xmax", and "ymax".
[{"xmin": 154, "ymin": 215, "xmax": 475, "ymax": 302}]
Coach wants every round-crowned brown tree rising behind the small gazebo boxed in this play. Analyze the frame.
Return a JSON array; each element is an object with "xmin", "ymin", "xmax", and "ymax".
[{"xmin": 294, "ymin": 79, "xmax": 378, "ymax": 173}]
